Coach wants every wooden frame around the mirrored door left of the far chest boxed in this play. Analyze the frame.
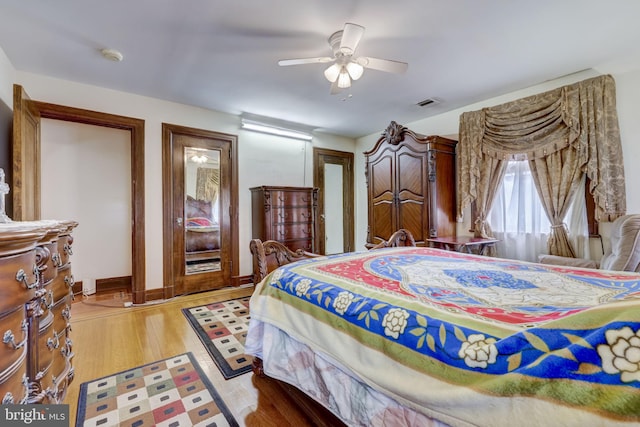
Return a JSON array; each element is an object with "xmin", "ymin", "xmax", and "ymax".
[{"xmin": 162, "ymin": 123, "xmax": 239, "ymax": 298}]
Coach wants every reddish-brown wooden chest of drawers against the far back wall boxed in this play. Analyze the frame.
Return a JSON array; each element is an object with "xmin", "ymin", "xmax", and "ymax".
[{"xmin": 251, "ymin": 186, "xmax": 318, "ymax": 252}]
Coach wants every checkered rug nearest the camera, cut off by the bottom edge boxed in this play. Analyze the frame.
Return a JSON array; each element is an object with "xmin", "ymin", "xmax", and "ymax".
[{"xmin": 76, "ymin": 353, "xmax": 238, "ymax": 427}]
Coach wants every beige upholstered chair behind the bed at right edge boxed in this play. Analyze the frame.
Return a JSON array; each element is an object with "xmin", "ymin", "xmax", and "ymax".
[{"xmin": 538, "ymin": 214, "xmax": 640, "ymax": 272}]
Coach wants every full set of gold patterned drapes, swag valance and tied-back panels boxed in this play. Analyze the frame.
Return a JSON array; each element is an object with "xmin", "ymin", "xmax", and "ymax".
[{"xmin": 457, "ymin": 75, "xmax": 626, "ymax": 256}]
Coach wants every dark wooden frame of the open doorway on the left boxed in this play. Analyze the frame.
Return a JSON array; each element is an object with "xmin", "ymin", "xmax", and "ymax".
[{"xmin": 11, "ymin": 85, "xmax": 146, "ymax": 304}]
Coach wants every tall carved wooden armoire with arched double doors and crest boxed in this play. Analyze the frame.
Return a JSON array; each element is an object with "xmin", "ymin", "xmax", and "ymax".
[{"xmin": 364, "ymin": 121, "xmax": 457, "ymax": 247}]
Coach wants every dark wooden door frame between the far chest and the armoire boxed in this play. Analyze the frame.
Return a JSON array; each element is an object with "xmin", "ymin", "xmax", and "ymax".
[{"xmin": 313, "ymin": 147, "xmax": 355, "ymax": 254}]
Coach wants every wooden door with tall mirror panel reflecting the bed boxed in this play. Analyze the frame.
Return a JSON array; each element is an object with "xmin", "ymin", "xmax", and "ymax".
[{"xmin": 163, "ymin": 124, "xmax": 237, "ymax": 295}]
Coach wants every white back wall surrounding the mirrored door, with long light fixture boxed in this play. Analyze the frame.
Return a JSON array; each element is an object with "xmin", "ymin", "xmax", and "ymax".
[{"xmin": 0, "ymin": 55, "xmax": 355, "ymax": 289}]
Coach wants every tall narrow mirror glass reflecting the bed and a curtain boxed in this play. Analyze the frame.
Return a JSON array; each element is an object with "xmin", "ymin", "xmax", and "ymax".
[{"xmin": 184, "ymin": 147, "xmax": 221, "ymax": 274}]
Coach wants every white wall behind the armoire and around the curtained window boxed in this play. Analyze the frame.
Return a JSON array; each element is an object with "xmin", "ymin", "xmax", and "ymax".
[{"xmin": 355, "ymin": 67, "xmax": 640, "ymax": 251}]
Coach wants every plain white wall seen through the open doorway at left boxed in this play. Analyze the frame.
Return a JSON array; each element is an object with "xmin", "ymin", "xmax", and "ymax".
[{"xmin": 40, "ymin": 119, "xmax": 132, "ymax": 293}]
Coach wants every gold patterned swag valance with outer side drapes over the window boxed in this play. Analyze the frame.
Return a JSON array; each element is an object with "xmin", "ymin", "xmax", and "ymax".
[{"xmin": 458, "ymin": 75, "xmax": 626, "ymax": 221}]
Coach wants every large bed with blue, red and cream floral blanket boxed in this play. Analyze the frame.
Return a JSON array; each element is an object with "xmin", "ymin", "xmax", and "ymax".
[{"xmin": 245, "ymin": 242, "xmax": 640, "ymax": 427}]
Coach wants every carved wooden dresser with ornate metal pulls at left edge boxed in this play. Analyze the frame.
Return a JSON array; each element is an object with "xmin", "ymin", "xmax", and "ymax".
[{"xmin": 0, "ymin": 221, "xmax": 78, "ymax": 404}]
